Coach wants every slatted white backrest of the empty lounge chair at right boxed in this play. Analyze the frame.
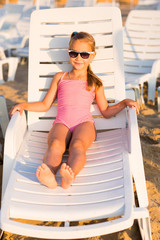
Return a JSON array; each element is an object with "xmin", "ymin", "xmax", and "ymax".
[{"xmin": 124, "ymin": 10, "xmax": 160, "ymax": 75}]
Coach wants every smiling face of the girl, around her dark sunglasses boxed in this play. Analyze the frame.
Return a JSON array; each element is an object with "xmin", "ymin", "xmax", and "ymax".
[{"xmin": 70, "ymin": 39, "xmax": 95, "ymax": 70}]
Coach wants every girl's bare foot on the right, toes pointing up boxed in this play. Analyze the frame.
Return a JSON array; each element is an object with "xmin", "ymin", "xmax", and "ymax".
[{"xmin": 60, "ymin": 163, "xmax": 74, "ymax": 188}]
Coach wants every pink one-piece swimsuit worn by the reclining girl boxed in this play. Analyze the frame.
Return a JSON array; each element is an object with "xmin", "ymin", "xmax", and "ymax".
[{"xmin": 53, "ymin": 73, "xmax": 95, "ymax": 132}]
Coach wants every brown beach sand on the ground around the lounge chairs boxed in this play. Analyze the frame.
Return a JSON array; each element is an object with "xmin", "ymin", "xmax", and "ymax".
[{"xmin": 0, "ymin": 0, "xmax": 160, "ymax": 240}]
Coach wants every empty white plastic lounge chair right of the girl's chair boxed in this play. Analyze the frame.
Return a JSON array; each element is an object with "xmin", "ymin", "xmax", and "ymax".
[{"xmin": 124, "ymin": 10, "xmax": 160, "ymax": 103}]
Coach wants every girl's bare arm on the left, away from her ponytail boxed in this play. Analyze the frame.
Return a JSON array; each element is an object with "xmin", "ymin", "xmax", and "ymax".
[{"xmin": 10, "ymin": 73, "xmax": 63, "ymax": 116}]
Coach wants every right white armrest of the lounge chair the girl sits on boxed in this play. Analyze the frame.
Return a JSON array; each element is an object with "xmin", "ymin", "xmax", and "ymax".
[{"xmin": 127, "ymin": 109, "xmax": 148, "ymax": 207}]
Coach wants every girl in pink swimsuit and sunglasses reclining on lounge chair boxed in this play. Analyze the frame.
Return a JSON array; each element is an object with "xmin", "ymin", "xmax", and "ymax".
[{"xmin": 11, "ymin": 32, "xmax": 139, "ymax": 188}]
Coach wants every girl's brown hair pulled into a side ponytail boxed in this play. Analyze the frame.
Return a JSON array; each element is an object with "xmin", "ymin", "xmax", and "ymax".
[{"xmin": 69, "ymin": 32, "xmax": 102, "ymax": 90}]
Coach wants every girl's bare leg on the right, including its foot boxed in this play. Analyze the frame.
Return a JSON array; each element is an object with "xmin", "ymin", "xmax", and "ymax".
[{"xmin": 60, "ymin": 122, "xmax": 96, "ymax": 188}]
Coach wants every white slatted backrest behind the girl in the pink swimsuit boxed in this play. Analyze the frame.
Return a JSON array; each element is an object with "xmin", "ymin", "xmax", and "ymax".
[{"xmin": 28, "ymin": 7, "xmax": 125, "ymax": 131}]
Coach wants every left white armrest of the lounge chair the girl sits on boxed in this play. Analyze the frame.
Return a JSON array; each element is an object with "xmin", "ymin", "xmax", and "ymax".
[{"xmin": 2, "ymin": 112, "xmax": 27, "ymax": 198}]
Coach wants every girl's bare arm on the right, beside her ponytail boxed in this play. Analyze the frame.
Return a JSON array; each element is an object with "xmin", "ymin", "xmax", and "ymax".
[{"xmin": 96, "ymin": 86, "xmax": 140, "ymax": 118}]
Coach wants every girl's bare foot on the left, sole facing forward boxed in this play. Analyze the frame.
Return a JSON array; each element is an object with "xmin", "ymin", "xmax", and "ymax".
[{"xmin": 36, "ymin": 163, "xmax": 57, "ymax": 188}]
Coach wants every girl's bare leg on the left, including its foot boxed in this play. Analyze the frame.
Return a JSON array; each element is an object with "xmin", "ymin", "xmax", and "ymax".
[{"xmin": 36, "ymin": 123, "xmax": 71, "ymax": 188}]
